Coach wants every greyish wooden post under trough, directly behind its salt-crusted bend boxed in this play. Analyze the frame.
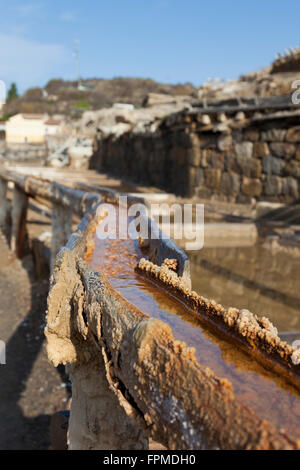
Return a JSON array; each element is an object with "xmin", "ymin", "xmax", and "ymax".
[{"xmin": 50, "ymin": 204, "xmax": 72, "ymax": 272}]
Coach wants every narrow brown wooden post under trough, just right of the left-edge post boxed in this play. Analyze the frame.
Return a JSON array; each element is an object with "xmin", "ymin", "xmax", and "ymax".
[{"xmin": 10, "ymin": 186, "xmax": 28, "ymax": 258}]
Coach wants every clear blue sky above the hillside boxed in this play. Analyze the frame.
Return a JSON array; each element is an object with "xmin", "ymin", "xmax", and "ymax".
[{"xmin": 0, "ymin": 0, "xmax": 300, "ymax": 91}]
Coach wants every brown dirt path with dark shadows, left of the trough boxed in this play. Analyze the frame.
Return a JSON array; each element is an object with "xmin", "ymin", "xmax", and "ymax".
[{"xmin": 0, "ymin": 236, "xmax": 67, "ymax": 449}]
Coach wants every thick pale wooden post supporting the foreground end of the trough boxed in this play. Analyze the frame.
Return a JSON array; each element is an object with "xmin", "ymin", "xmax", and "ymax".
[{"xmin": 68, "ymin": 353, "xmax": 148, "ymax": 450}]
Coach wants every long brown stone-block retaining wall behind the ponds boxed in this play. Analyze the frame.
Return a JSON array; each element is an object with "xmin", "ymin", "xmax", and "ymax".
[{"xmin": 90, "ymin": 111, "xmax": 300, "ymax": 202}]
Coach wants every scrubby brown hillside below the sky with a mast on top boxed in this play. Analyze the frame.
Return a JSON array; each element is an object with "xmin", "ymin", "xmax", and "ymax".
[{"xmin": 2, "ymin": 78, "xmax": 197, "ymax": 118}]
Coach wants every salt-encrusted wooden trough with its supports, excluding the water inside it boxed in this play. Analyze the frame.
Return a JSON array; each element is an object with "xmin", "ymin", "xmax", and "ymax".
[{"xmin": 0, "ymin": 170, "xmax": 300, "ymax": 449}]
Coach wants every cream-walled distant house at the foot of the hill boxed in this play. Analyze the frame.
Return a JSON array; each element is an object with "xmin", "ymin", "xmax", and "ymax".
[{"xmin": 6, "ymin": 114, "xmax": 61, "ymax": 144}]
